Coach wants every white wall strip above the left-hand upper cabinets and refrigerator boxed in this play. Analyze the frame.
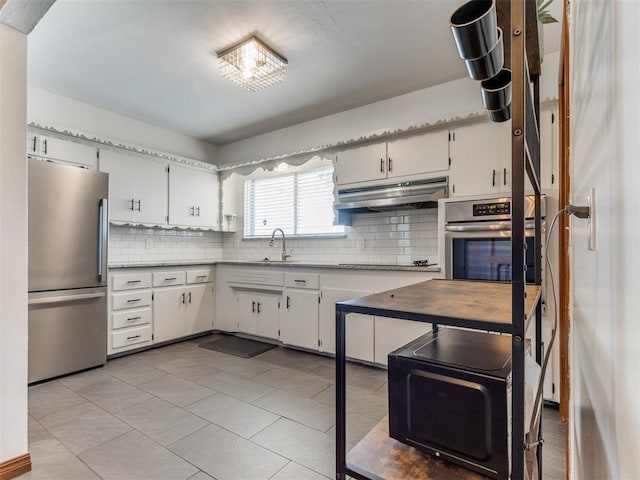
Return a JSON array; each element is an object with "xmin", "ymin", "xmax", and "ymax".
[{"xmin": 27, "ymin": 87, "xmax": 218, "ymax": 163}]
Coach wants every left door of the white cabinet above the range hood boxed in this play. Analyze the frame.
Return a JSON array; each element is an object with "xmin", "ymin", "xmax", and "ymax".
[{"xmin": 334, "ymin": 142, "xmax": 387, "ymax": 185}]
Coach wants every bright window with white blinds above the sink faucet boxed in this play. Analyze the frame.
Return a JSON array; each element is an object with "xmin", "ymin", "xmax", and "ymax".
[{"xmin": 244, "ymin": 167, "xmax": 344, "ymax": 237}]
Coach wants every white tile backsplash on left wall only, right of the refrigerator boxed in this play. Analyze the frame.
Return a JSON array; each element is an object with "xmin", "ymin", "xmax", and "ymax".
[{"xmin": 109, "ymin": 225, "xmax": 222, "ymax": 264}]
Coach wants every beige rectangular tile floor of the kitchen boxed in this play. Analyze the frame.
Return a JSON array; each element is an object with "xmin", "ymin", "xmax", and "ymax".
[{"xmin": 21, "ymin": 338, "xmax": 564, "ymax": 480}]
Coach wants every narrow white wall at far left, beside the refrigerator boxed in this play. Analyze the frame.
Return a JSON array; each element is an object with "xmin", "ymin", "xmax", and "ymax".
[{"xmin": 0, "ymin": 24, "xmax": 27, "ymax": 463}]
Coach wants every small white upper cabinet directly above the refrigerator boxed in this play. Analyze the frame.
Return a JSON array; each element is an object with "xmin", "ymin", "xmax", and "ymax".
[{"xmin": 27, "ymin": 132, "xmax": 98, "ymax": 168}]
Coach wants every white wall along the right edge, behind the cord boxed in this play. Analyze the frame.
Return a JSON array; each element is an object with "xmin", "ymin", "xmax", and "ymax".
[{"xmin": 570, "ymin": 0, "xmax": 640, "ymax": 480}]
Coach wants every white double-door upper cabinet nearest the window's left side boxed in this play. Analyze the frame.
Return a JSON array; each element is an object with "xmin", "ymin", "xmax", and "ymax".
[{"xmin": 169, "ymin": 165, "xmax": 219, "ymax": 229}]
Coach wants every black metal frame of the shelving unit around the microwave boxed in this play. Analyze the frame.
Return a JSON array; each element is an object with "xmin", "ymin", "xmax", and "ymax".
[{"xmin": 336, "ymin": 0, "xmax": 543, "ymax": 480}]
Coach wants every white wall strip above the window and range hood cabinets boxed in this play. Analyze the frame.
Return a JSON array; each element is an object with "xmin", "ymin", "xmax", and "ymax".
[{"xmin": 218, "ymin": 52, "xmax": 559, "ymax": 165}]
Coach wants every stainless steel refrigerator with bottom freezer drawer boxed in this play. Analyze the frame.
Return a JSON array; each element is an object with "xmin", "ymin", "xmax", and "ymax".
[{"xmin": 28, "ymin": 159, "xmax": 109, "ymax": 383}]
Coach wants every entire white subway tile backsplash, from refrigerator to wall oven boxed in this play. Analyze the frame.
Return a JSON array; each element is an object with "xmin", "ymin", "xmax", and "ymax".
[{"xmin": 109, "ymin": 209, "xmax": 438, "ymax": 264}]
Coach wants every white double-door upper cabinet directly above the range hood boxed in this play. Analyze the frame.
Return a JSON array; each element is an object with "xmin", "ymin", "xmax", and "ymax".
[{"xmin": 335, "ymin": 129, "xmax": 449, "ymax": 185}]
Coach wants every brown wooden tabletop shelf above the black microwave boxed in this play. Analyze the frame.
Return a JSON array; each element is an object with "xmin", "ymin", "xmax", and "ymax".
[{"xmin": 337, "ymin": 279, "xmax": 540, "ymax": 332}]
